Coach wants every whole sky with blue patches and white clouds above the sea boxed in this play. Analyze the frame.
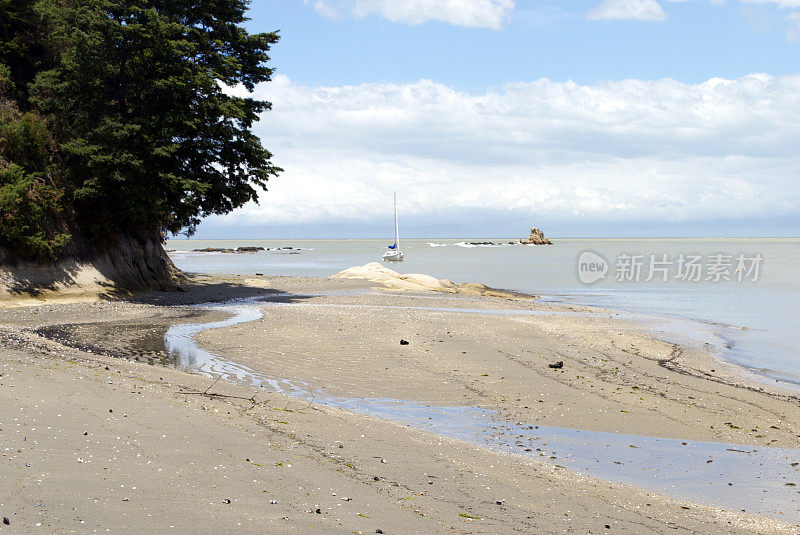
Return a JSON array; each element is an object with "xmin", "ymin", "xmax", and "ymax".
[{"xmin": 191, "ymin": 0, "xmax": 800, "ymax": 238}]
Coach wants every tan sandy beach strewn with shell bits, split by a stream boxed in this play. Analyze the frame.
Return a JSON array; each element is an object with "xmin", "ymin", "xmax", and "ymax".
[{"xmin": 0, "ymin": 275, "xmax": 800, "ymax": 533}]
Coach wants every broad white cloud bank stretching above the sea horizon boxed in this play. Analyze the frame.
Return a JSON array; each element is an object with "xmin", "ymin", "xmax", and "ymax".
[{"xmin": 221, "ymin": 74, "xmax": 800, "ymax": 224}]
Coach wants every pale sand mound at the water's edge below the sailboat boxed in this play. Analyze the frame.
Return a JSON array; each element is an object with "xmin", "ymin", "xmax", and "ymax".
[{"xmin": 331, "ymin": 262, "xmax": 533, "ymax": 299}]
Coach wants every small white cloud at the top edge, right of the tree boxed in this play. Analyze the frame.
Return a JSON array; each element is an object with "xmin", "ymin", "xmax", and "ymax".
[{"xmin": 305, "ymin": 0, "xmax": 514, "ymax": 29}]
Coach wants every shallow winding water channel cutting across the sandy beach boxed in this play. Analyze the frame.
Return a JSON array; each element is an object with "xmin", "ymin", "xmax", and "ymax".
[{"xmin": 164, "ymin": 299, "xmax": 800, "ymax": 523}]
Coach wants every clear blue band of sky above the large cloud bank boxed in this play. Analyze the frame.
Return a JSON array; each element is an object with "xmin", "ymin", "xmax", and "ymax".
[{"xmin": 248, "ymin": 0, "xmax": 800, "ymax": 90}]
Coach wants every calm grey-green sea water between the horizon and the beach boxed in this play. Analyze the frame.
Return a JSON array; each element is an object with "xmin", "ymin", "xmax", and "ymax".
[{"xmin": 167, "ymin": 238, "xmax": 800, "ymax": 387}]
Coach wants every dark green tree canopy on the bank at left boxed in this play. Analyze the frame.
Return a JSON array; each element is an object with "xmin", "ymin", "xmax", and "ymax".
[{"xmin": 0, "ymin": 0, "xmax": 280, "ymax": 257}]
